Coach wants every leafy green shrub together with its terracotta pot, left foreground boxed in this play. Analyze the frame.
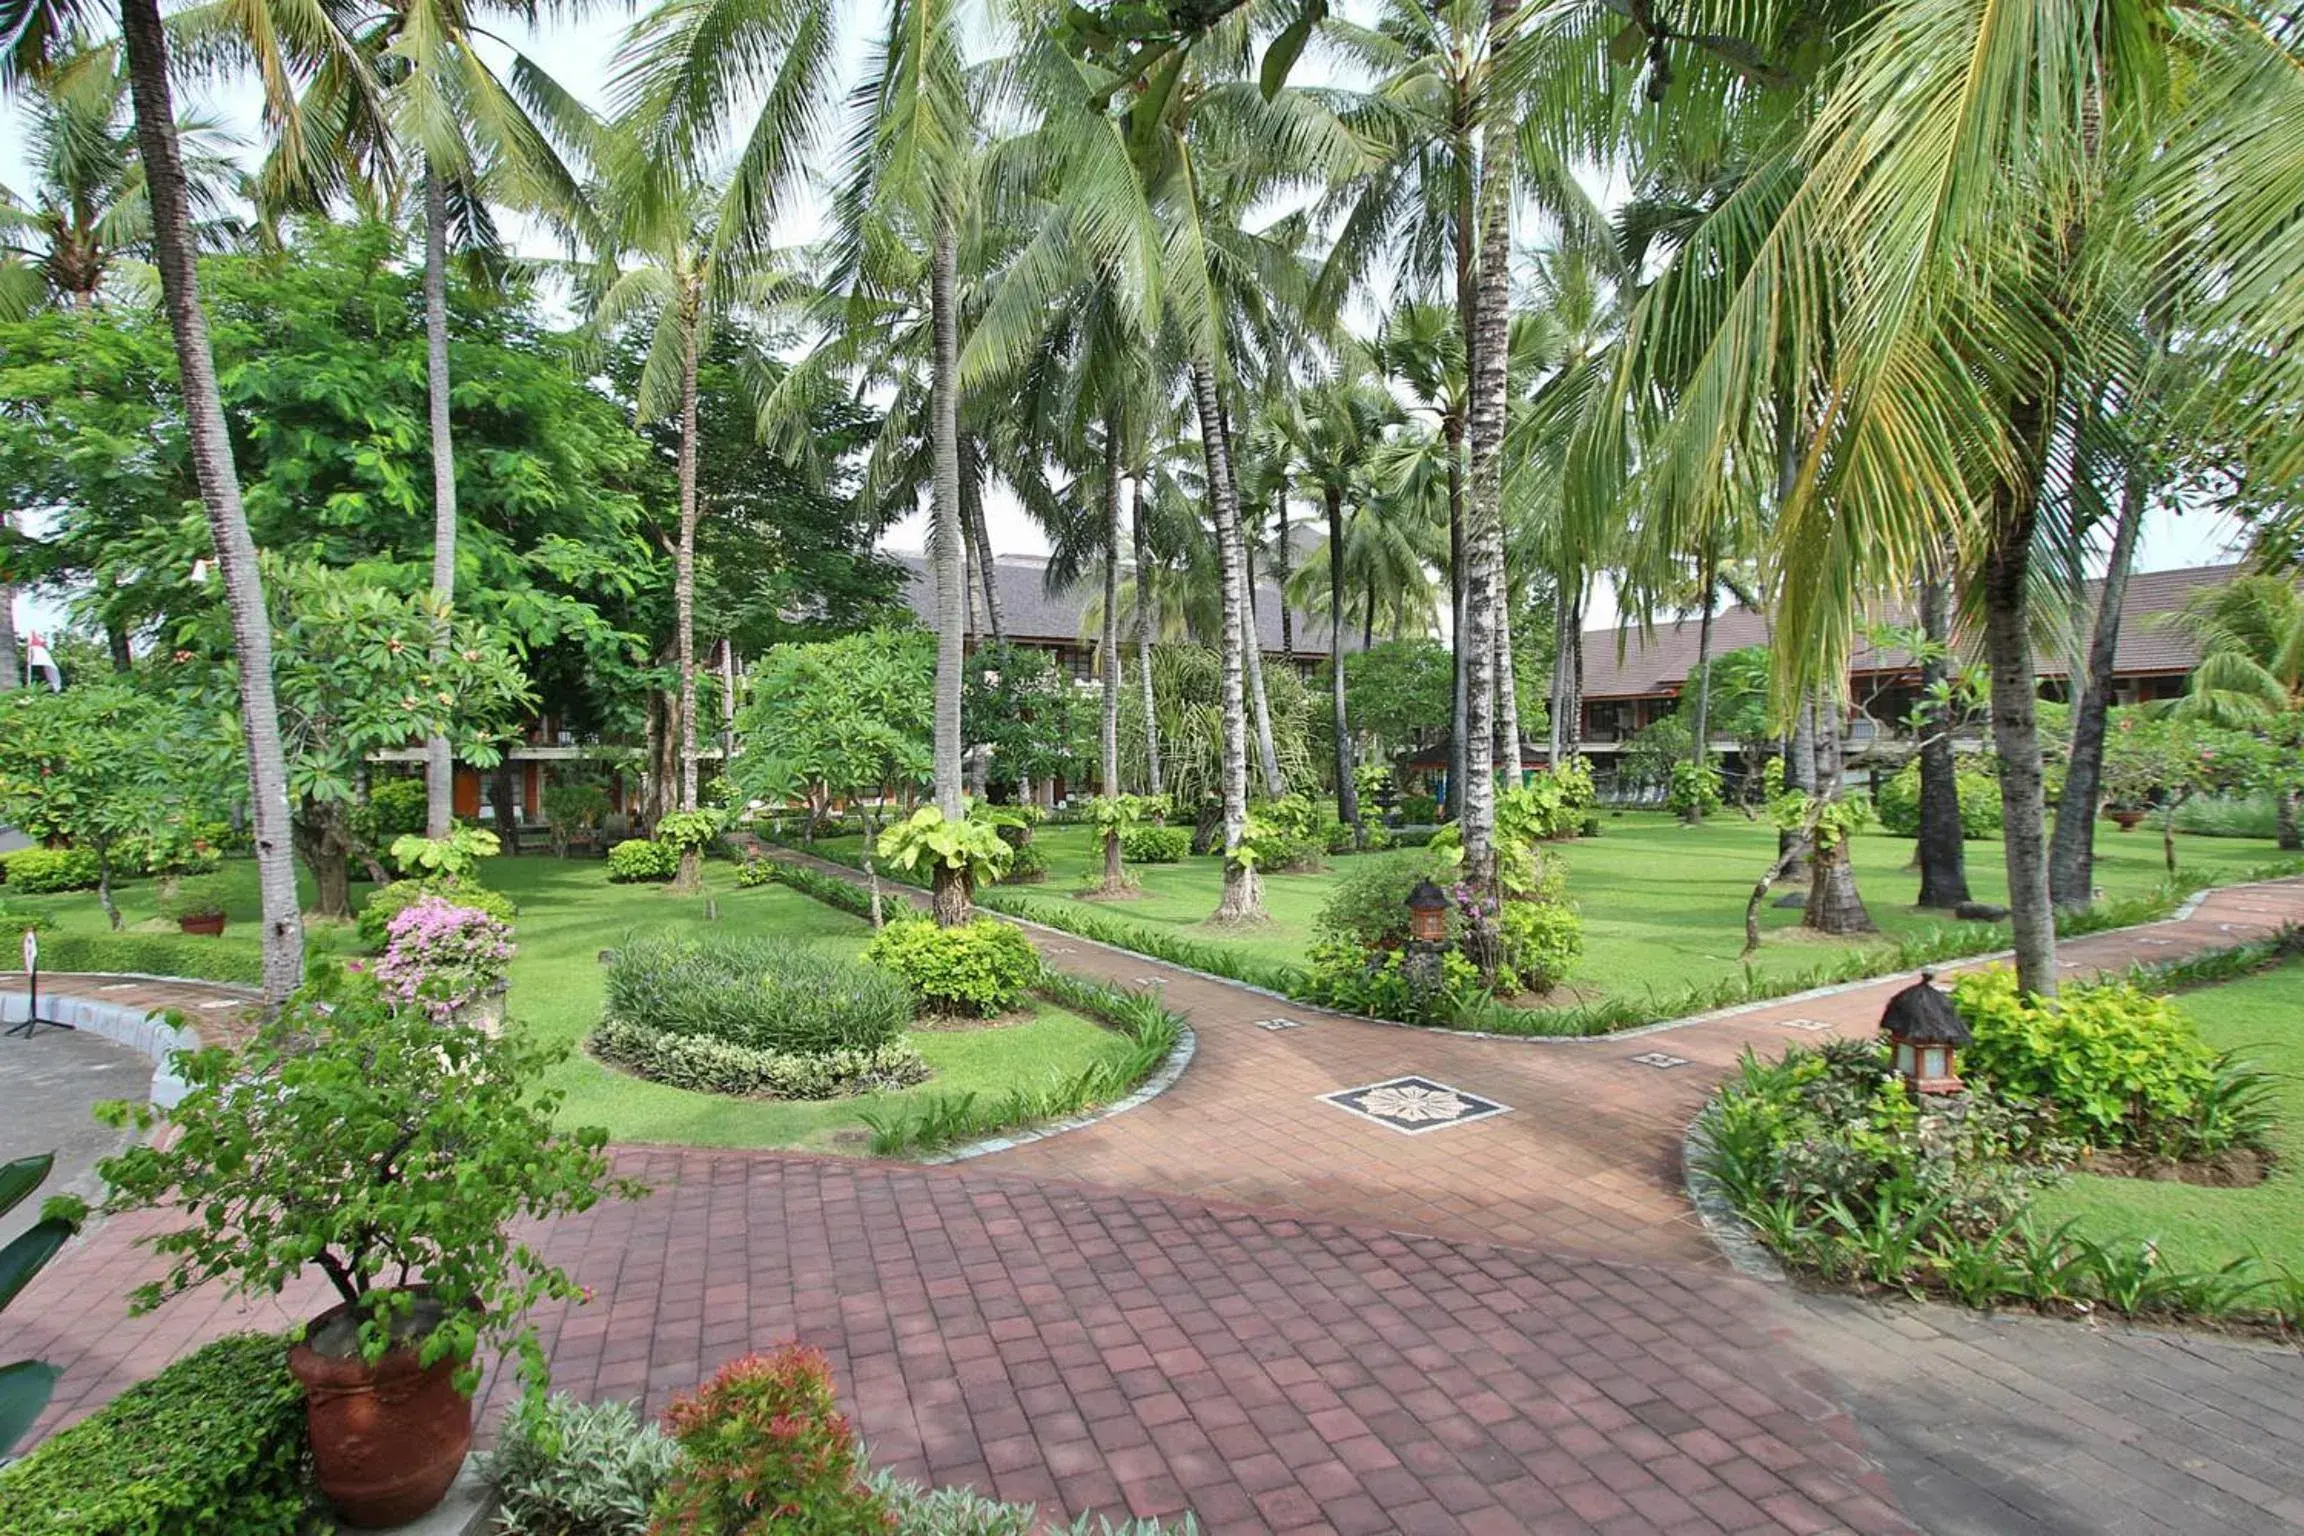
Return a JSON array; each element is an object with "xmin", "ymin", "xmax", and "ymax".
[{"xmin": 101, "ymin": 967, "xmax": 638, "ymax": 1527}]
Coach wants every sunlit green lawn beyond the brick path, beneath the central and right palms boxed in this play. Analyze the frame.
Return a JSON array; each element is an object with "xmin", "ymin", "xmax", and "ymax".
[{"xmin": 825, "ymin": 811, "xmax": 2279, "ymax": 1002}]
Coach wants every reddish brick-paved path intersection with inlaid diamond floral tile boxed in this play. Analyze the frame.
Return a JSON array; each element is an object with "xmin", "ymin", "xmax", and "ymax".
[{"xmin": 0, "ymin": 882, "xmax": 2304, "ymax": 1534}]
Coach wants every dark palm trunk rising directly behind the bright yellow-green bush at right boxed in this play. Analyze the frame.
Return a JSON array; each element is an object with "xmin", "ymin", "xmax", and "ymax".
[{"xmin": 1979, "ymin": 394, "xmax": 2055, "ymax": 997}]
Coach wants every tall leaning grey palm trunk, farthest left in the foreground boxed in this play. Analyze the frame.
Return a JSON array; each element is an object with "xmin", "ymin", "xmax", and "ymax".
[{"xmin": 120, "ymin": 0, "xmax": 304, "ymax": 1004}]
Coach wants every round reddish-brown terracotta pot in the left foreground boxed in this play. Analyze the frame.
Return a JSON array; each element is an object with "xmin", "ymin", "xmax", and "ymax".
[{"xmin": 288, "ymin": 1303, "xmax": 472, "ymax": 1527}]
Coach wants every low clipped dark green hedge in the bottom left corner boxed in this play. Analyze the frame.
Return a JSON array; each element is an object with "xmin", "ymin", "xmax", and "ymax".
[{"xmin": 0, "ymin": 1333, "xmax": 306, "ymax": 1536}]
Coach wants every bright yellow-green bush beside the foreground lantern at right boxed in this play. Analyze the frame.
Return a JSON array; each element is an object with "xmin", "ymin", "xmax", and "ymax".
[{"xmin": 1951, "ymin": 967, "xmax": 2219, "ymax": 1154}]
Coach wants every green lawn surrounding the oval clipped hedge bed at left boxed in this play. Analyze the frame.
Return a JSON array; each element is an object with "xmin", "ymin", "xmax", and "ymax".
[{"xmin": 9, "ymin": 857, "xmax": 1127, "ymax": 1151}]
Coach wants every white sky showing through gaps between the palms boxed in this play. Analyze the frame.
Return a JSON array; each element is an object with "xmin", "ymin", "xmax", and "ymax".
[{"xmin": 0, "ymin": 0, "xmax": 2235, "ymax": 629}]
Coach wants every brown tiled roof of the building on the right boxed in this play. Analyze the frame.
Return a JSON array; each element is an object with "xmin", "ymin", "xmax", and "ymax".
[{"xmin": 1583, "ymin": 564, "xmax": 2244, "ymax": 698}]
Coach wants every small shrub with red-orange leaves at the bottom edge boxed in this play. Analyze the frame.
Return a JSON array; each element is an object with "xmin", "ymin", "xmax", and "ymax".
[{"xmin": 650, "ymin": 1345, "xmax": 896, "ymax": 1536}]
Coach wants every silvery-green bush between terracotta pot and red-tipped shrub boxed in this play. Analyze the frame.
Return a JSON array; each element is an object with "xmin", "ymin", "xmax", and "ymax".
[{"xmin": 488, "ymin": 1393, "xmax": 680, "ymax": 1536}]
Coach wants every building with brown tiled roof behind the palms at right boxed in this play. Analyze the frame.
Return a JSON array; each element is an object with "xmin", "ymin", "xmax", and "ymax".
[{"xmin": 1583, "ymin": 564, "xmax": 2246, "ymax": 753}]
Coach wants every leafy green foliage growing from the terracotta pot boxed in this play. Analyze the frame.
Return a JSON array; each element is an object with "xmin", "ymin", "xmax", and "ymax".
[{"xmin": 97, "ymin": 967, "xmax": 631, "ymax": 1391}]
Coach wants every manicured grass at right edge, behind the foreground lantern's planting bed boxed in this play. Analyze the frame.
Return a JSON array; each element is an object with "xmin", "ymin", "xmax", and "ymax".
[{"xmin": 2037, "ymin": 960, "xmax": 2304, "ymax": 1276}]
